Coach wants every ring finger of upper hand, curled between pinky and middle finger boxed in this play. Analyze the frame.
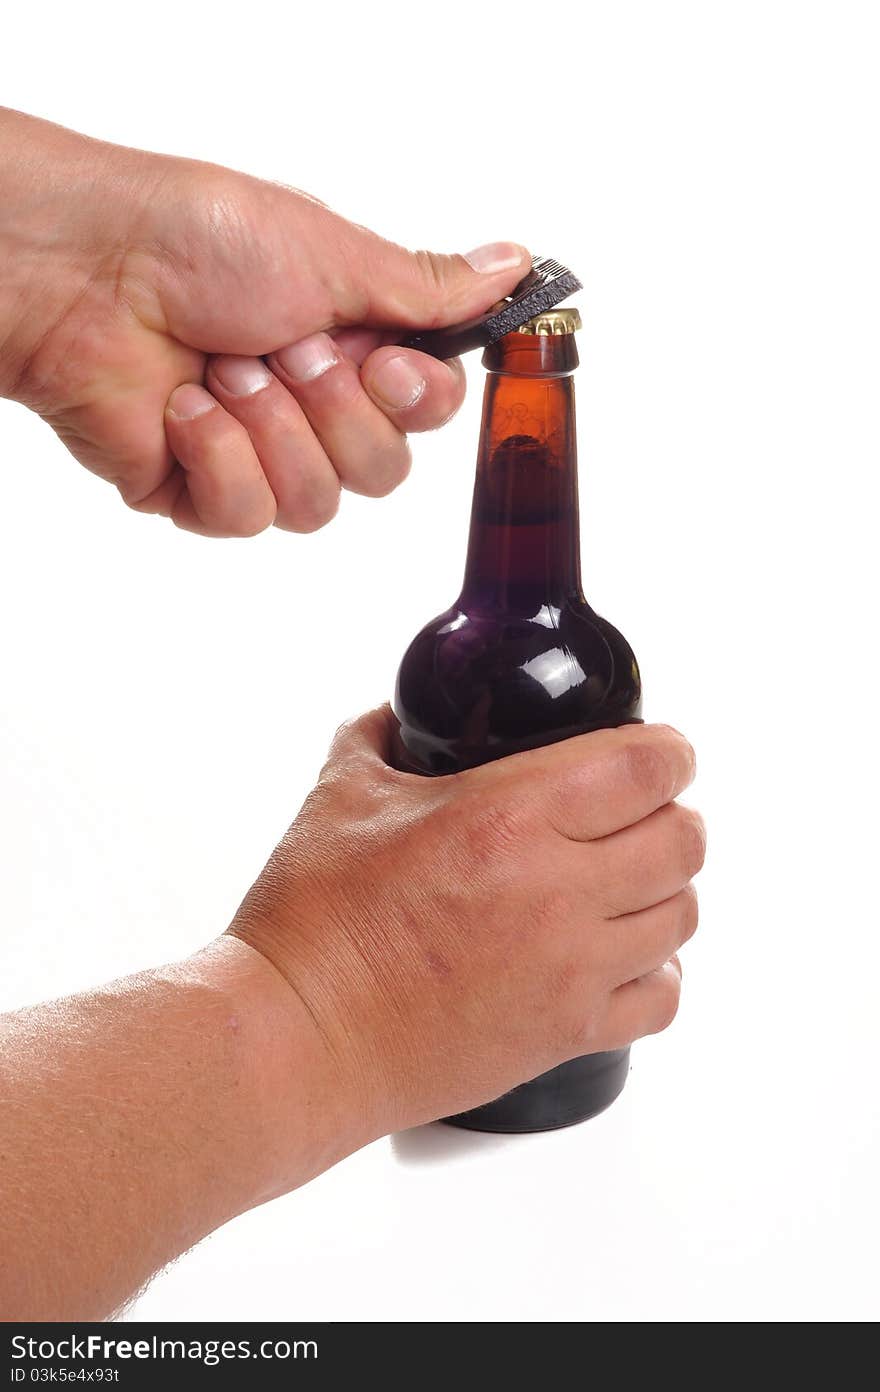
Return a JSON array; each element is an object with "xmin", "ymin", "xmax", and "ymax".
[{"xmin": 206, "ymin": 356, "xmax": 340, "ymax": 532}]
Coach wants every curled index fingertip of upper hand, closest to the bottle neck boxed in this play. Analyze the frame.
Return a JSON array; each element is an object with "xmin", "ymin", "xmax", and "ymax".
[{"xmin": 361, "ymin": 347, "xmax": 465, "ymax": 432}]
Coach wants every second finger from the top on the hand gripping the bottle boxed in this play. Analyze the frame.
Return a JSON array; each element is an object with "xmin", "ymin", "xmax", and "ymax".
[{"xmin": 589, "ymin": 802, "xmax": 706, "ymax": 923}]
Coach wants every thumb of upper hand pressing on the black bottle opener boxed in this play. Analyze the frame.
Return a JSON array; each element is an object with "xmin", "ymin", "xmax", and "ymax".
[{"xmin": 330, "ymin": 223, "xmax": 532, "ymax": 329}]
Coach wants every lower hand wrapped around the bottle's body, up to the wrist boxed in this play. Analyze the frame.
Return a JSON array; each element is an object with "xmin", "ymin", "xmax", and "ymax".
[{"xmin": 230, "ymin": 707, "xmax": 705, "ymax": 1140}]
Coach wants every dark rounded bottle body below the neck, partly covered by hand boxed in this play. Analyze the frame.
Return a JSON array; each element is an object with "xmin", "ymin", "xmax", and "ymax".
[{"xmin": 393, "ymin": 606, "xmax": 641, "ymax": 1133}]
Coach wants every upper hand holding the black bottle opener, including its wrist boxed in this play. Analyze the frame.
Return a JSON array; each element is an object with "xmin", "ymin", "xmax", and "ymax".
[{"xmin": 0, "ymin": 111, "xmax": 529, "ymax": 536}]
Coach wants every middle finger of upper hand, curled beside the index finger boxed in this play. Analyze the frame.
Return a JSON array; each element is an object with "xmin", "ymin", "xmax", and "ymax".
[{"xmin": 269, "ymin": 333, "xmax": 409, "ymax": 498}]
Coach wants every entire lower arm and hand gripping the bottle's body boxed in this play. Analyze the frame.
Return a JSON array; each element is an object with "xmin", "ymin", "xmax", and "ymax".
[{"xmin": 0, "ymin": 707, "xmax": 705, "ymax": 1320}]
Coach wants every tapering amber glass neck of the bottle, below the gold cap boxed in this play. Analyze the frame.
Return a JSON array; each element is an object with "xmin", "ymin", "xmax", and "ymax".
[{"xmin": 459, "ymin": 334, "xmax": 582, "ymax": 615}]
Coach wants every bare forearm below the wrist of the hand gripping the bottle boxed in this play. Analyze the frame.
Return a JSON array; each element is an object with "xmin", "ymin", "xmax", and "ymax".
[{"xmin": 0, "ymin": 937, "xmax": 369, "ymax": 1320}]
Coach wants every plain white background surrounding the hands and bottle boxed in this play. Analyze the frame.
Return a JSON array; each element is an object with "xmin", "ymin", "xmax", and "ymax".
[{"xmin": 0, "ymin": 0, "xmax": 880, "ymax": 1321}]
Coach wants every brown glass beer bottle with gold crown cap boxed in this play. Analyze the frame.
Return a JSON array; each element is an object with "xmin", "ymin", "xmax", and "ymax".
[{"xmin": 393, "ymin": 309, "xmax": 641, "ymax": 1132}]
